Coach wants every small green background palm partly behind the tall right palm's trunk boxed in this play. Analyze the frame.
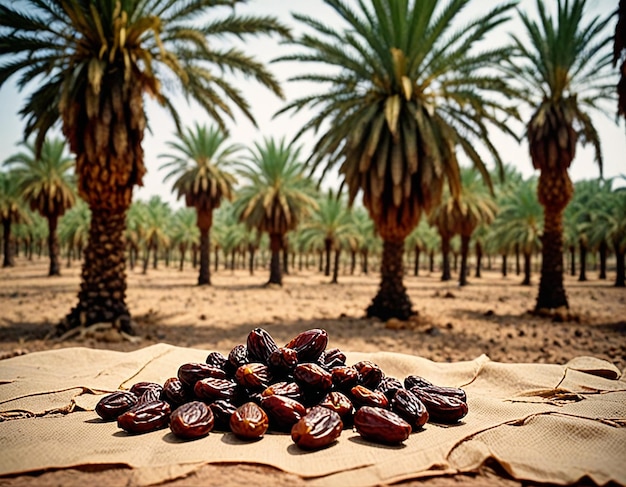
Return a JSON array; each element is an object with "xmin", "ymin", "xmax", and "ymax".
[{"xmin": 491, "ymin": 178, "xmax": 543, "ymax": 286}]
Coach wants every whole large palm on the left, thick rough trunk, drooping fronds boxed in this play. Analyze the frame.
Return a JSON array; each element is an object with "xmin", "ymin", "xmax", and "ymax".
[{"xmin": 0, "ymin": 0, "xmax": 288, "ymax": 333}]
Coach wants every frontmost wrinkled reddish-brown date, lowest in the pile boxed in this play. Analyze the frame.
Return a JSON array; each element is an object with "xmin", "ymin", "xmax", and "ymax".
[{"xmin": 291, "ymin": 406, "xmax": 343, "ymax": 450}]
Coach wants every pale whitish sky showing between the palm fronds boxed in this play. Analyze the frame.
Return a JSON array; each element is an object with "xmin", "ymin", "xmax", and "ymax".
[{"xmin": 0, "ymin": 0, "xmax": 626, "ymax": 206}]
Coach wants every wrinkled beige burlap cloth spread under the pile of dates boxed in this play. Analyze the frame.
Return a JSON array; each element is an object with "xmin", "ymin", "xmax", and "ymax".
[{"xmin": 0, "ymin": 344, "xmax": 626, "ymax": 486}]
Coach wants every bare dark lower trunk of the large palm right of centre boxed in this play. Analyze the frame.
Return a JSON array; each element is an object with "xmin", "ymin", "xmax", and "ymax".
[{"xmin": 367, "ymin": 240, "xmax": 415, "ymax": 321}]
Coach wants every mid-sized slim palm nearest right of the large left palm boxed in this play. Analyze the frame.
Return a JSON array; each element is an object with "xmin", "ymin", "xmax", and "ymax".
[{"xmin": 161, "ymin": 124, "xmax": 240, "ymax": 285}]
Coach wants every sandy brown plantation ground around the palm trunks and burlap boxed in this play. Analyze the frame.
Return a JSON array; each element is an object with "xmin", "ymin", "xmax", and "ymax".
[{"xmin": 0, "ymin": 259, "xmax": 626, "ymax": 487}]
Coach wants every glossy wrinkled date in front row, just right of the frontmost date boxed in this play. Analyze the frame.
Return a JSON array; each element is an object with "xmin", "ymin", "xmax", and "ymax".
[{"xmin": 354, "ymin": 406, "xmax": 412, "ymax": 445}]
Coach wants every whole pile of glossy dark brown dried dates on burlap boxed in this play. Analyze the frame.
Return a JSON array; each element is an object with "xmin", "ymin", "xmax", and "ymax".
[{"xmin": 96, "ymin": 328, "xmax": 467, "ymax": 450}]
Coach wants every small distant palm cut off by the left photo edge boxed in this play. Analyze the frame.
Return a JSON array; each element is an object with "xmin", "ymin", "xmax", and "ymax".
[{"xmin": 0, "ymin": 171, "xmax": 28, "ymax": 267}]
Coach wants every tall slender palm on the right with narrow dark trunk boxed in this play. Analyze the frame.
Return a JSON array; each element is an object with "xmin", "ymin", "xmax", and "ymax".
[{"xmin": 507, "ymin": 0, "xmax": 615, "ymax": 312}]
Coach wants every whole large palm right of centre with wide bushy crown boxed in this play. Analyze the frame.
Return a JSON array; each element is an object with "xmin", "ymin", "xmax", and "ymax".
[{"xmin": 282, "ymin": 0, "xmax": 516, "ymax": 319}]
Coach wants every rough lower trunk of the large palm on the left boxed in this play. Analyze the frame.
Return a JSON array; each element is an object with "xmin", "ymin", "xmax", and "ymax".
[{"xmin": 58, "ymin": 207, "xmax": 135, "ymax": 334}]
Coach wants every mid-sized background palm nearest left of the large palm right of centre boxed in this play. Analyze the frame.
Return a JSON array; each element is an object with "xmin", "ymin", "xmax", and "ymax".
[{"xmin": 234, "ymin": 138, "xmax": 317, "ymax": 285}]
